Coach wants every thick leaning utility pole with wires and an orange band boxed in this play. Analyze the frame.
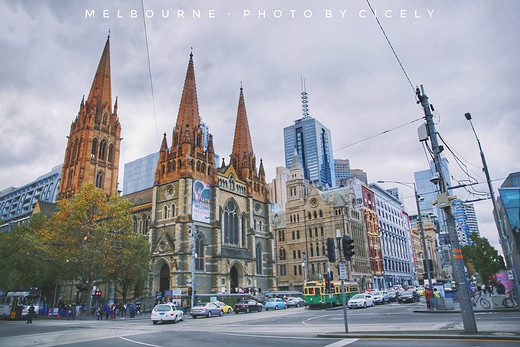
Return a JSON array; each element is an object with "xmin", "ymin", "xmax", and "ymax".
[{"xmin": 416, "ymin": 85, "xmax": 477, "ymax": 333}]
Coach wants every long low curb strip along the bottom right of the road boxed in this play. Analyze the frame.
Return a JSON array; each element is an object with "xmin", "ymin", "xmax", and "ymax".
[{"xmin": 318, "ymin": 331, "xmax": 520, "ymax": 341}]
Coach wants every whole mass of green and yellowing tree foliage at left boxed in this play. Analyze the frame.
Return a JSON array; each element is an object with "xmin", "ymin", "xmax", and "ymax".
[{"xmin": 0, "ymin": 184, "xmax": 150, "ymax": 312}]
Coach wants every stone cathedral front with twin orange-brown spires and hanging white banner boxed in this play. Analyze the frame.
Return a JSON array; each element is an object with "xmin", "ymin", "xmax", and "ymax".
[{"xmin": 125, "ymin": 54, "xmax": 276, "ymax": 294}]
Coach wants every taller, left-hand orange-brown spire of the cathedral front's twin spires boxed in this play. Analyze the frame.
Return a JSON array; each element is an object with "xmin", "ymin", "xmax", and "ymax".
[{"xmin": 175, "ymin": 53, "xmax": 200, "ymax": 129}]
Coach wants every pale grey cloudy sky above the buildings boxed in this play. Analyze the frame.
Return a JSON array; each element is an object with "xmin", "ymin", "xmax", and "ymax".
[{"xmin": 0, "ymin": 0, "xmax": 520, "ymax": 254}]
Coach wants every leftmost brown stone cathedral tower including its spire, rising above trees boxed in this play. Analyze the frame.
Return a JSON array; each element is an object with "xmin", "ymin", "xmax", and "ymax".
[{"xmin": 58, "ymin": 35, "xmax": 121, "ymax": 199}]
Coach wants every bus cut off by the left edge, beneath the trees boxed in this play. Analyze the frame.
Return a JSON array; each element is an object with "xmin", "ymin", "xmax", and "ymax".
[{"xmin": 0, "ymin": 288, "xmax": 41, "ymax": 319}]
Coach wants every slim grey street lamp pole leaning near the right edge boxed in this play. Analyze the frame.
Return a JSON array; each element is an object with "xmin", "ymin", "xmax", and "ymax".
[{"xmin": 464, "ymin": 113, "xmax": 520, "ymax": 304}]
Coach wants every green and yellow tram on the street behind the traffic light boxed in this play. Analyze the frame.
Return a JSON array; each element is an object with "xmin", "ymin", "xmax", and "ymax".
[{"xmin": 303, "ymin": 281, "xmax": 359, "ymax": 308}]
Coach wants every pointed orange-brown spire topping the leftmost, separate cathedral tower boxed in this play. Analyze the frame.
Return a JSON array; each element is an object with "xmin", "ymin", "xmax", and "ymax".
[{"xmin": 87, "ymin": 34, "xmax": 112, "ymax": 110}]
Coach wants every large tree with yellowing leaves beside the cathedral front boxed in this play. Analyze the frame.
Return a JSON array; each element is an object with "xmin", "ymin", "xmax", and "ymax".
[{"xmin": 45, "ymin": 184, "xmax": 149, "ymax": 314}]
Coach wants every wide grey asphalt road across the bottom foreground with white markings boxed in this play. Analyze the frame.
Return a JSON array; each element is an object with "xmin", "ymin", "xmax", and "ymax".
[{"xmin": 0, "ymin": 303, "xmax": 520, "ymax": 347}]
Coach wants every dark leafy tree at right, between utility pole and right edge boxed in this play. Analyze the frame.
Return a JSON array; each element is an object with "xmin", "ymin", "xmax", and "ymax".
[{"xmin": 462, "ymin": 233, "xmax": 504, "ymax": 282}]
